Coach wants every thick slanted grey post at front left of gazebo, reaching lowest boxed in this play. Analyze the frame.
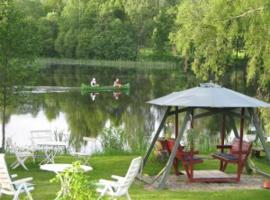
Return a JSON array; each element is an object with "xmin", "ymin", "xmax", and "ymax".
[{"xmin": 158, "ymin": 110, "xmax": 191, "ymax": 188}]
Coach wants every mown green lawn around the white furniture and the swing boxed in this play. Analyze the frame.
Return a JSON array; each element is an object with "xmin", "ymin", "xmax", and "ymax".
[{"xmin": 1, "ymin": 155, "xmax": 270, "ymax": 200}]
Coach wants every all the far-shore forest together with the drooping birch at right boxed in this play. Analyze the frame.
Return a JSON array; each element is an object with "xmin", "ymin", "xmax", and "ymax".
[{"xmin": 2, "ymin": 0, "xmax": 270, "ymax": 91}]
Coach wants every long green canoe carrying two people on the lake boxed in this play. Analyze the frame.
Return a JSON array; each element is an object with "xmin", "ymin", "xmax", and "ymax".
[{"xmin": 81, "ymin": 83, "xmax": 130, "ymax": 93}]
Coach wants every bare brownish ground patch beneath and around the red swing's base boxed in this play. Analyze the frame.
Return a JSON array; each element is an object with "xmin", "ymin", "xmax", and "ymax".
[{"xmin": 143, "ymin": 173, "xmax": 265, "ymax": 191}]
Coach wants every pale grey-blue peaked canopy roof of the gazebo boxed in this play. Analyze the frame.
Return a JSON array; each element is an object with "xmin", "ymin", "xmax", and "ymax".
[{"xmin": 147, "ymin": 83, "xmax": 270, "ymax": 108}]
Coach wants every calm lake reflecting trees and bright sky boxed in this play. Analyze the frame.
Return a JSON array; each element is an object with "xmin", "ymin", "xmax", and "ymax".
[{"xmin": 1, "ymin": 65, "xmax": 260, "ymax": 152}]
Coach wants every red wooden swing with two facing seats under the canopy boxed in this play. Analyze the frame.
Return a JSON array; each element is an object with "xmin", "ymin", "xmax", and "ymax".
[{"xmin": 159, "ymin": 109, "xmax": 252, "ymax": 182}]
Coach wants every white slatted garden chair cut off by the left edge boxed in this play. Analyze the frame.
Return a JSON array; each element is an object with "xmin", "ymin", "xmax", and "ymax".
[{"xmin": 0, "ymin": 154, "xmax": 34, "ymax": 200}]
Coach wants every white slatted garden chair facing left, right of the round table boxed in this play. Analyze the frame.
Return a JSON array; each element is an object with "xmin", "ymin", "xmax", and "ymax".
[{"xmin": 97, "ymin": 157, "xmax": 142, "ymax": 200}]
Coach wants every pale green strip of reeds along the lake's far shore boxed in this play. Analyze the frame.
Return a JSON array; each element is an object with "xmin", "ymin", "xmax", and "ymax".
[{"xmin": 37, "ymin": 58, "xmax": 178, "ymax": 70}]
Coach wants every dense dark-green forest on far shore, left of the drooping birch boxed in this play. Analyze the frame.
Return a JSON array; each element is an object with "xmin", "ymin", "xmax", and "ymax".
[{"xmin": 16, "ymin": 0, "xmax": 178, "ymax": 60}]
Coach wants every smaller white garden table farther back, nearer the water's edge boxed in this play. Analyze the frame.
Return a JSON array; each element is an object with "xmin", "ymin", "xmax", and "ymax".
[{"xmin": 36, "ymin": 141, "xmax": 67, "ymax": 164}]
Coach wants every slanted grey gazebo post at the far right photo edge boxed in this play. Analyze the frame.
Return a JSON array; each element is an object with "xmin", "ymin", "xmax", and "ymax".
[{"xmin": 248, "ymin": 108, "xmax": 270, "ymax": 161}]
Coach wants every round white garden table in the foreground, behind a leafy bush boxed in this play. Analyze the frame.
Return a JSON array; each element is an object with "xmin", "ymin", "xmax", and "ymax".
[{"xmin": 40, "ymin": 164, "xmax": 93, "ymax": 199}]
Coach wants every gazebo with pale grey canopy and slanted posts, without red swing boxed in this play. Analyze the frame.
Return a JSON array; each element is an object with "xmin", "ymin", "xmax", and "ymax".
[{"xmin": 143, "ymin": 83, "xmax": 270, "ymax": 188}]
